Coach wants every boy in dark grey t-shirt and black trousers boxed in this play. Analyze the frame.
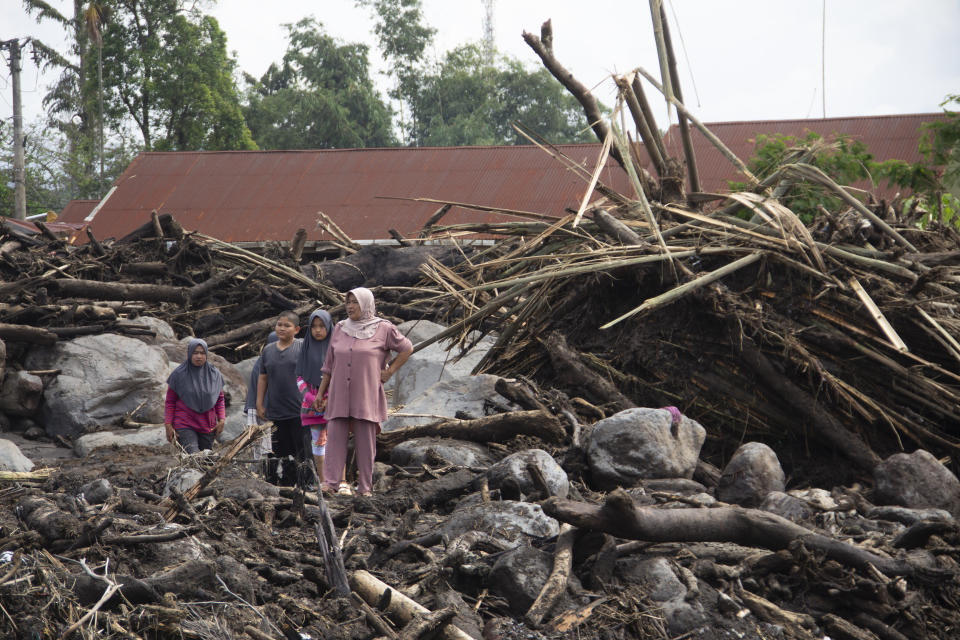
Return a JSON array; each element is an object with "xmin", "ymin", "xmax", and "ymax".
[{"xmin": 257, "ymin": 311, "xmax": 310, "ymax": 486}]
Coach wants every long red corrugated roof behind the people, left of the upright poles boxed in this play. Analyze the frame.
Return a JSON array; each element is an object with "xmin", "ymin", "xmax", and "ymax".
[{"xmin": 65, "ymin": 145, "xmax": 628, "ymax": 242}]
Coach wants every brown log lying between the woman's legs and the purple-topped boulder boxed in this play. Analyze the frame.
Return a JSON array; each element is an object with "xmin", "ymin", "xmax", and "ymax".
[{"xmin": 377, "ymin": 411, "xmax": 565, "ymax": 451}]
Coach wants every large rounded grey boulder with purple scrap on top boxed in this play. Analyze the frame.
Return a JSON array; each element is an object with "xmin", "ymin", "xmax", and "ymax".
[{"xmin": 587, "ymin": 408, "xmax": 707, "ymax": 489}]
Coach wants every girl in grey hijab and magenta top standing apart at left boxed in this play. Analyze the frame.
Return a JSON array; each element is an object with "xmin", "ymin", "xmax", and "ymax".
[{"xmin": 163, "ymin": 338, "xmax": 226, "ymax": 453}]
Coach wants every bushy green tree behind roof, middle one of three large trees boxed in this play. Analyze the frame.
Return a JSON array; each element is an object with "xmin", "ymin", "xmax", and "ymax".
[{"xmin": 243, "ymin": 18, "xmax": 395, "ymax": 149}]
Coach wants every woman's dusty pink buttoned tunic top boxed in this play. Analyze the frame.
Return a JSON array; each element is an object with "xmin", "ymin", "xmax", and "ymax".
[{"xmin": 322, "ymin": 320, "xmax": 413, "ymax": 424}]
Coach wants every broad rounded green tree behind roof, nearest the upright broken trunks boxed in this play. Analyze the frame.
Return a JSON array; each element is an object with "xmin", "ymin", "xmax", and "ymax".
[{"xmin": 408, "ymin": 44, "xmax": 591, "ymax": 146}]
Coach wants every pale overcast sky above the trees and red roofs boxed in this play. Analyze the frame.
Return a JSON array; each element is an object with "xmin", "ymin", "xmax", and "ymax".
[{"xmin": 0, "ymin": 0, "xmax": 960, "ymax": 136}]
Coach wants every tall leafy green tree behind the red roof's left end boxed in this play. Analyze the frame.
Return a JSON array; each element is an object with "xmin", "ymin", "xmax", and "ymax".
[{"xmin": 103, "ymin": 0, "xmax": 256, "ymax": 151}]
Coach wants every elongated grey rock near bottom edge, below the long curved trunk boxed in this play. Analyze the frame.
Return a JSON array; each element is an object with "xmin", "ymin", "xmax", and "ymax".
[{"xmin": 617, "ymin": 557, "xmax": 707, "ymax": 636}]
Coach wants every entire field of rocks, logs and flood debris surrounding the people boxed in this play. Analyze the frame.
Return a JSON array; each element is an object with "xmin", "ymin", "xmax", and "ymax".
[{"xmin": 0, "ymin": 127, "xmax": 960, "ymax": 640}]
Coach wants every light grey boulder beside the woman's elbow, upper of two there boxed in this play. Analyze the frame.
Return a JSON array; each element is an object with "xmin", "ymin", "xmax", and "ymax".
[{"xmin": 385, "ymin": 320, "xmax": 495, "ymax": 405}]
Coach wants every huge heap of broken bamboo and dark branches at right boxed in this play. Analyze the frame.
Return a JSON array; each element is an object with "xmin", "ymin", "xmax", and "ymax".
[{"xmin": 408, "ymin": 154, "xmax": 960, "ymax": 484}]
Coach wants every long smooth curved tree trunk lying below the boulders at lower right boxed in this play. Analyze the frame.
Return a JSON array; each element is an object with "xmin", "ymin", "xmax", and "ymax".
[{"xmin": 542, "ymin": 489, "xmax": 953, "ymax": 579}]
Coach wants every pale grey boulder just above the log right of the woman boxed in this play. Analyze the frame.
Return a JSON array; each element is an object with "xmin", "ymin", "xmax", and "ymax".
[{"xmin": 383, "ymin": 376, "xmax": 516, "ymax": 431}]
